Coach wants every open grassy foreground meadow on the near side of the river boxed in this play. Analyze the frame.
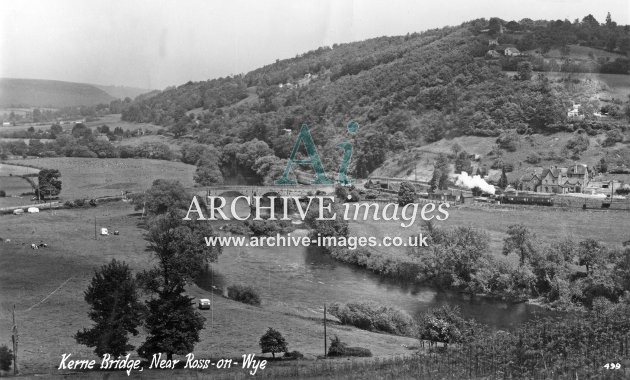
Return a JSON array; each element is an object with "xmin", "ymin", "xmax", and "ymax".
[{"xmin": 0, "ymin": 202, "xmax": 417, "ymax": 376}]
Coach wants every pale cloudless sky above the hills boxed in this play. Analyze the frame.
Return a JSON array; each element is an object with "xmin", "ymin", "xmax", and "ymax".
[{"xmin": 0, "ymin": 0, "xmax": 630, "ymax": 89}]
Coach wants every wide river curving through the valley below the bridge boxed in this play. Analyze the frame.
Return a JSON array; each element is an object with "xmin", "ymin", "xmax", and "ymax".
[{"xmin": 197, "ymin": 199, "xmax": 548, "ymax": 329}]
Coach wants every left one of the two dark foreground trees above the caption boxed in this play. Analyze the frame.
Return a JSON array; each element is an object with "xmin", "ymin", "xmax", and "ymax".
[{"xmin": 75, "ymin": 259, "xmax": 143, "ymax": 356}]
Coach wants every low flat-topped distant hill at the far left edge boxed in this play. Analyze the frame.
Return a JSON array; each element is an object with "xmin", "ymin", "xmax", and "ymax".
[{"xmin": 0, "ymin": 78, "xmax": 115, "ymax": 108}]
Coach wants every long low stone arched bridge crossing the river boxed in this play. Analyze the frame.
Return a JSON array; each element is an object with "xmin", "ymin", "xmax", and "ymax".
[{"xmin": 206, "ymin": 185, "xmax": 335, "ymax": 197}]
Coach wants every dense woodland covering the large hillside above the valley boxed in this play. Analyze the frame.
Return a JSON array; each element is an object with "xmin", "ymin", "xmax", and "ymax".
[{"xmin": 116, "ymin": 15, "xmax": 630, "ymax": 177}]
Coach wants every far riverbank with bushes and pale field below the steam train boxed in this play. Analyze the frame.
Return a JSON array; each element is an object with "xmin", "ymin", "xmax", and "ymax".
[{"xmin": 320, "ymin": 202, "xmax": 630, "ymax": 311}]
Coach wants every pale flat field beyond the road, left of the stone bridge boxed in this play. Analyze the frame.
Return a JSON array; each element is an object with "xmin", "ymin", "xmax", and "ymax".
[{"xmin": 10, "ymin": 157, "xmax": 195, "ymax": 199}]
